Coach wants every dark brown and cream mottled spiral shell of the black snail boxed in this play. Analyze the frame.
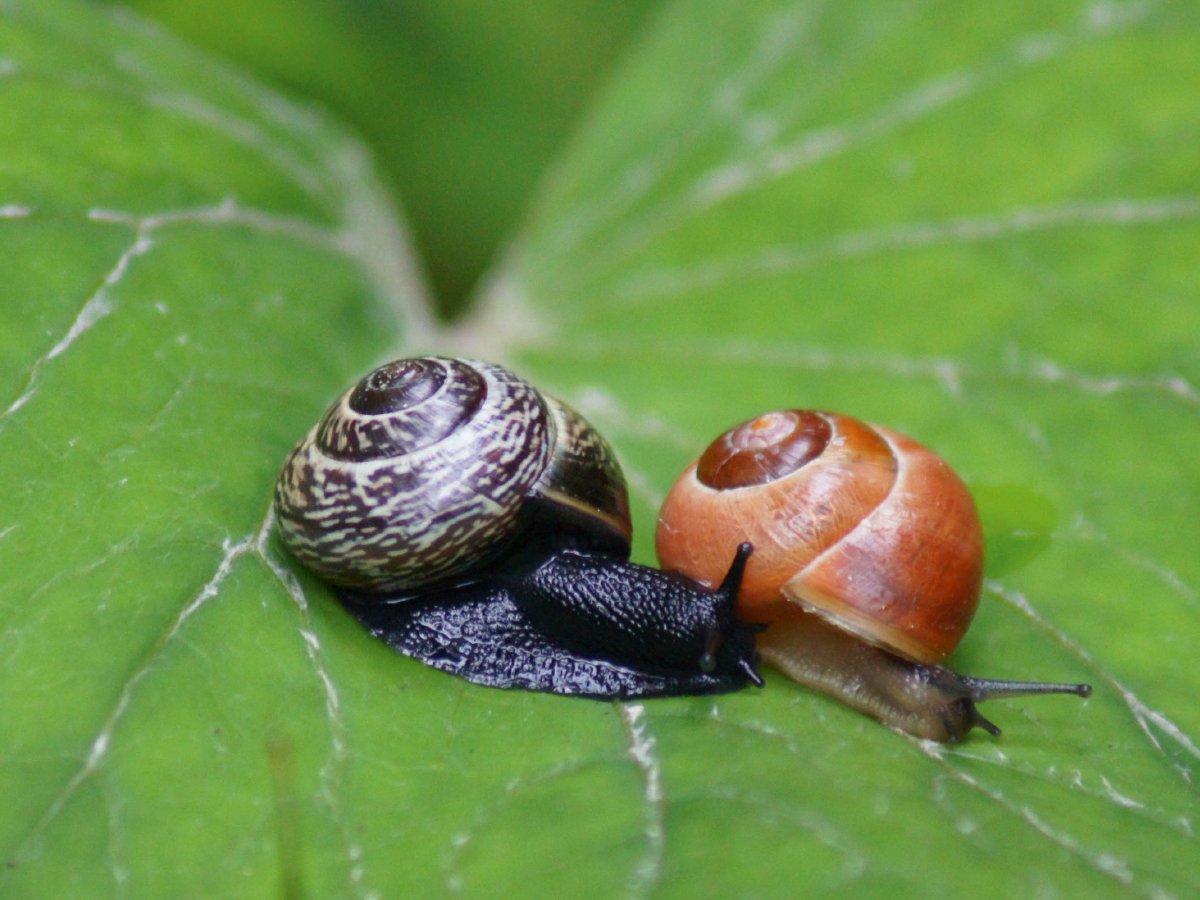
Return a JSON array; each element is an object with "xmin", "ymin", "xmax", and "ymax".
[{"xmin": 275, "ymin": 358, "xmax": 629, "ymax": 594}]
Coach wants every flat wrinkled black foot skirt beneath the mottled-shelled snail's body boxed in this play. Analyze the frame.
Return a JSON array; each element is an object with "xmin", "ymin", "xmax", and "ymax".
[{"xmin": 340, "ymin": 584, "xmax": 757, "ymax": 700}]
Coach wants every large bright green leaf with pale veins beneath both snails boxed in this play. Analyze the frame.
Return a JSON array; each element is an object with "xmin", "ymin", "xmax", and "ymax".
[{"xmin": 0, "ymin": 0, "xmax": 1200, "ymax": 900}]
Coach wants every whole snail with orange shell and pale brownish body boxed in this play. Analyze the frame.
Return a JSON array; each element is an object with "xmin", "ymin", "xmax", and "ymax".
[{"xmin": 655, "ymin": 409, "xmax": 1092, "ymax": 742}]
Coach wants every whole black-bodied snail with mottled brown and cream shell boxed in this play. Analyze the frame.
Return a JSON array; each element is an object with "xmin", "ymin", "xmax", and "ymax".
[{"xmin": 275, "ymin": 358, "xmax": 762, "ymax": 698}]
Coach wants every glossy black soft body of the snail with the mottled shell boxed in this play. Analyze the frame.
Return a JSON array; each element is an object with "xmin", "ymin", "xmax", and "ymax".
[{"xmin": 340, "ymin": 545, "xmax": 761, "ymax": 700}]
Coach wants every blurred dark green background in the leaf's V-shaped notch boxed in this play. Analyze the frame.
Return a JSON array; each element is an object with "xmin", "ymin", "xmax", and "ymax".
[{"xmin": 103, "ymin": 0, "xmax": 655, "ymax": 316}]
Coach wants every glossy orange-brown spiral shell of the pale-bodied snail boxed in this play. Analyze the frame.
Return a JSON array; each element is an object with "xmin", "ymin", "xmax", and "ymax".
[{"xmin": 655, "ymin": 410, "xmax": 984, "ymax": 662}]
